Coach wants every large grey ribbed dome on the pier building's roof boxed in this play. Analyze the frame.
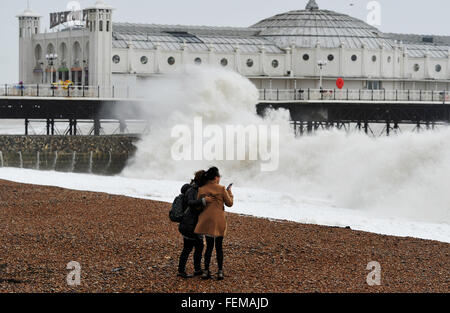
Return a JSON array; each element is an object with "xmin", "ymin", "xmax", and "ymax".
[{"xmin": 251, "ymin": 0, "xmax": 393, "ymax": 49}]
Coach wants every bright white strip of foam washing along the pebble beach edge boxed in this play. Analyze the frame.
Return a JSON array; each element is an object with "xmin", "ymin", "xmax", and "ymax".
[{"xmin": 0, "ymin": 168, "xmax": 450, "ymax": 243}]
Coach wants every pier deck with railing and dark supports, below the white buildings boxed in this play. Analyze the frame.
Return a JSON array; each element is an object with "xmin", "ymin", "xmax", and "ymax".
[{"xmin": 0, "ymin": 85, "xmax": 450, "ymax": 136}]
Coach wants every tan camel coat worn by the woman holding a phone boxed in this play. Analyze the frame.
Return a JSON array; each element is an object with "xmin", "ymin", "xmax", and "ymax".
[{"xmin": 195, "ymin": 182, "xmax": 233, "ymax": 237}]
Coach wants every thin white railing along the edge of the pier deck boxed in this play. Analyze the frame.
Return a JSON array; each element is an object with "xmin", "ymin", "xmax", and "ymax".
[{"xmin": 0, "ymin": 84, "xmax": 450, "ymax": 102}]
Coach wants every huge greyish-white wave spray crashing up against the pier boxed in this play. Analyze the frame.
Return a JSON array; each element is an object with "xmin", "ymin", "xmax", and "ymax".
[{"xmin": 123, "ymin": 69, "xmax": 450, "ymax": 223}]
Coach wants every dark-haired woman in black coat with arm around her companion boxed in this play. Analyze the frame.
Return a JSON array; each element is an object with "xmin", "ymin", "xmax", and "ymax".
[{"xmin": 178, "ymin": 171, "xmax": 211, "ymax": 278}]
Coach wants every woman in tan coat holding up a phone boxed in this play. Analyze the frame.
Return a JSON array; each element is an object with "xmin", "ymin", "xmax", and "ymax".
[{"xmin": 195, "ymin": 167, "xmax": 233, "ymax": 280}]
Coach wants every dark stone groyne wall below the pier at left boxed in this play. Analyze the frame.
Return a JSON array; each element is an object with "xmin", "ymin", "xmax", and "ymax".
[{"xmin": 0, "ymin": 135, "xmax": 139, "ymax": 175}]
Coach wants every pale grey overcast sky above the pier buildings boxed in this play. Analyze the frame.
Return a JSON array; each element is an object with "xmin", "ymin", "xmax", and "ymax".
[{"xmin": 0, "ymin": 0, "xmax": 450, "ymax": 83}]
